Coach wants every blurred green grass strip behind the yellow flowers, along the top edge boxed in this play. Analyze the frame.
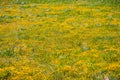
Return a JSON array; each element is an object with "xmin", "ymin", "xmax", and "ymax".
[{"xmin": 0, "ymin": 0, "xmax": 120, "ymax": 5}]
